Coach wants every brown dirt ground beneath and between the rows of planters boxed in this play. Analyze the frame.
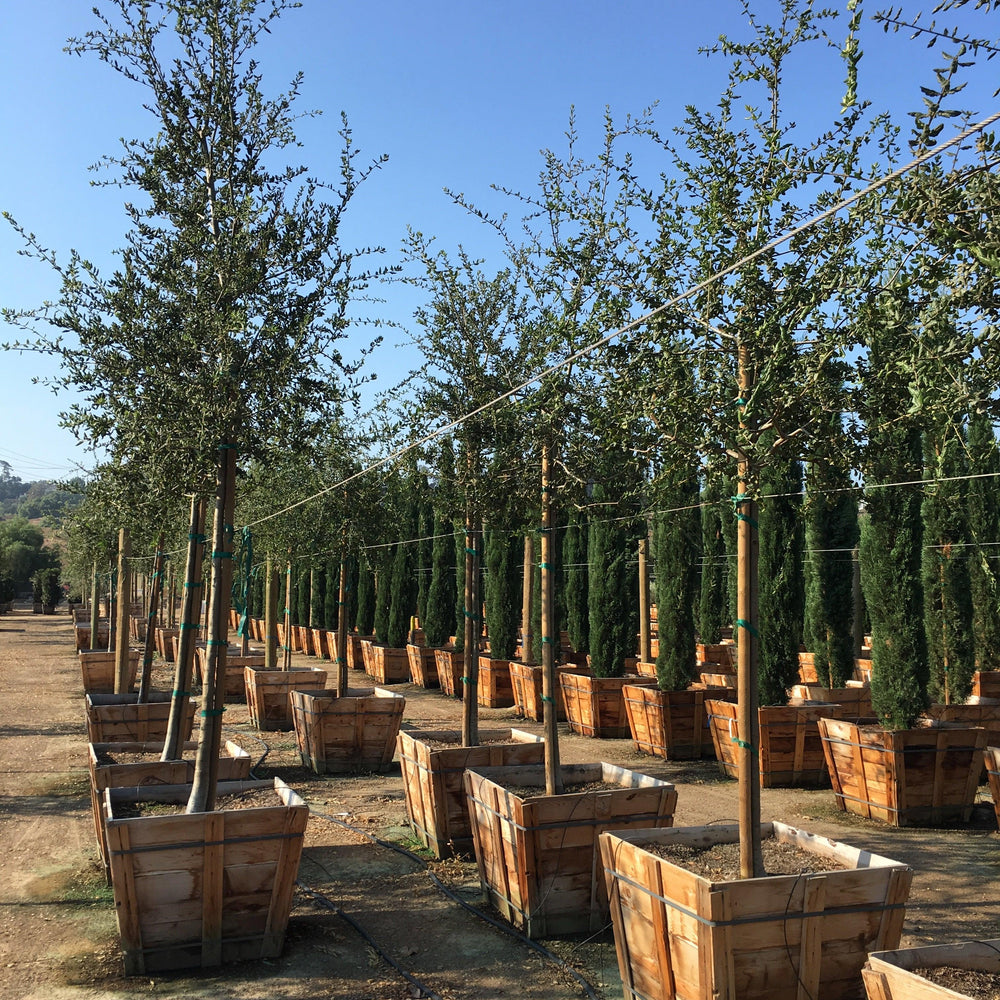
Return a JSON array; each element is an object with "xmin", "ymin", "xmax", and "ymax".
[{"xmin": 0, "ymin": 610, "xmax": 1000, "ymax": 1000}]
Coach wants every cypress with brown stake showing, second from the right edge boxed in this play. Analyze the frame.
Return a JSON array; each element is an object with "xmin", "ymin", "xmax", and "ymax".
[{"xmin": 922, "ymin": 423, "xmax": 975, "ymax": 704}]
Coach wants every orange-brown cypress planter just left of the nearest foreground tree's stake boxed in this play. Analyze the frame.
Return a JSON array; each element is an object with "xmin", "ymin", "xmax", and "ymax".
[{"xmin": 622, "ymin": 684, "xmax": 714, "ymax": 760}]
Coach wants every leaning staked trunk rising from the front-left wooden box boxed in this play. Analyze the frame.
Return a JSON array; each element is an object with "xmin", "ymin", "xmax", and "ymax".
[{"xmin": 187, "ymin": 444, "xmax": 236, "ymax": 813}]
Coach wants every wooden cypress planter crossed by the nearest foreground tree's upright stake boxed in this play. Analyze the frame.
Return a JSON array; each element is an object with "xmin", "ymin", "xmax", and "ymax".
[{"xmin": 705, "ymin": 700, "xmax": 836, "ymax": 788}]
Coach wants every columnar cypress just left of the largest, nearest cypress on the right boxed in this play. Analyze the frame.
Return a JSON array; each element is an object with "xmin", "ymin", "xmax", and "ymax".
[{"xmin": 804, "ymin": 463, "xmax": 859, "ymax": 687}]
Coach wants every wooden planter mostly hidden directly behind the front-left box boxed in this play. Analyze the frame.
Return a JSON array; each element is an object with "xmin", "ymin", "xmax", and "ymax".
[{"xmin": 90, "ymin": 740, "xmax": 251, "ymax": 881}]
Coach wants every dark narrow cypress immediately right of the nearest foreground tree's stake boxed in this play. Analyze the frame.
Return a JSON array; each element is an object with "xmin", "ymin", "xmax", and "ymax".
[{"xmin": 758, "ymin": 450, "xmax": 805, "ymax": 705}]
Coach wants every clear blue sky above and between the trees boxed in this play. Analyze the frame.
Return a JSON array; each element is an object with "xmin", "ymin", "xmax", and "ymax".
[{"xmin": 0, "ymin": 0, "xmax": 997, "ymax": 481}]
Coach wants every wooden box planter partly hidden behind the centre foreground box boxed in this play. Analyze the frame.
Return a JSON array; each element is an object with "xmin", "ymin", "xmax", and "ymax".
[{"xmin": 396, "ymin": 729, "xmax": 545, "ymax": 858}]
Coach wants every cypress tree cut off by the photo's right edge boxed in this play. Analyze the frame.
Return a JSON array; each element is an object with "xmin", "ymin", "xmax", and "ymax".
[{"xmin": 968, "ymin": 414, "xmax": 1000, "ymax": 670}]
